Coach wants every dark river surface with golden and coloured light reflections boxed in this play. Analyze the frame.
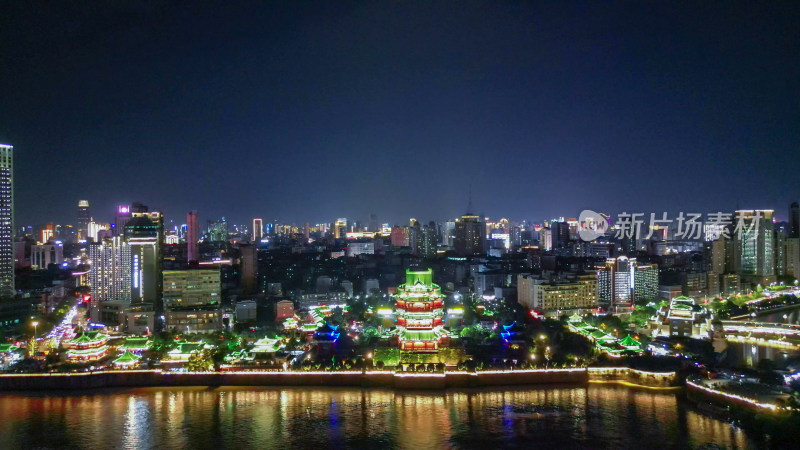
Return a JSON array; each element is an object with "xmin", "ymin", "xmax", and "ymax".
[{"xmin": 0, "ymin": 386, "xmax": 757, "ymax": 449}]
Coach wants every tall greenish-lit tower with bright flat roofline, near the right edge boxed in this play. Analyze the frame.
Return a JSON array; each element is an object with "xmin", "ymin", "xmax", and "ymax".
[{"xmin": 733, "ymin": 210, "xmax": 775, "ymax": 286}]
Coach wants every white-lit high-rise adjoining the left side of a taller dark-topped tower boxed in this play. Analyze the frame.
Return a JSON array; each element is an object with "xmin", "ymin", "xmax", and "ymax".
[{"xmin": 89, "ymin": 236, "xmax": 133, "ymax": 319}]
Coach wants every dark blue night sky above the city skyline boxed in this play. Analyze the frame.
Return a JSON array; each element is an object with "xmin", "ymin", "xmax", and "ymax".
[{"xmin": 0, "ymin": 0, "xmax": 800, "ymax": 229}]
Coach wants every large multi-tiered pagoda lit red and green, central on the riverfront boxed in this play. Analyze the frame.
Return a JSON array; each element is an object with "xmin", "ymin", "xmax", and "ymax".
[{"xmin": 395, "ymin": 269, "xmax": 448, "ymax": 353}]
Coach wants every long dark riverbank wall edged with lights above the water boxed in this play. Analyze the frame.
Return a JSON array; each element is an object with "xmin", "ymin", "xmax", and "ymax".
[{"xmin": 0, "ymin": 367, "xmax": 678, "ymax": 391}]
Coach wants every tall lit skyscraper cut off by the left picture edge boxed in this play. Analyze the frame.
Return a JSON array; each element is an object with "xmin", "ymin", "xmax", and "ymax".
[{"xmin": 0, "ymin": 144, "xmax": 16, "ymax": 297}]
